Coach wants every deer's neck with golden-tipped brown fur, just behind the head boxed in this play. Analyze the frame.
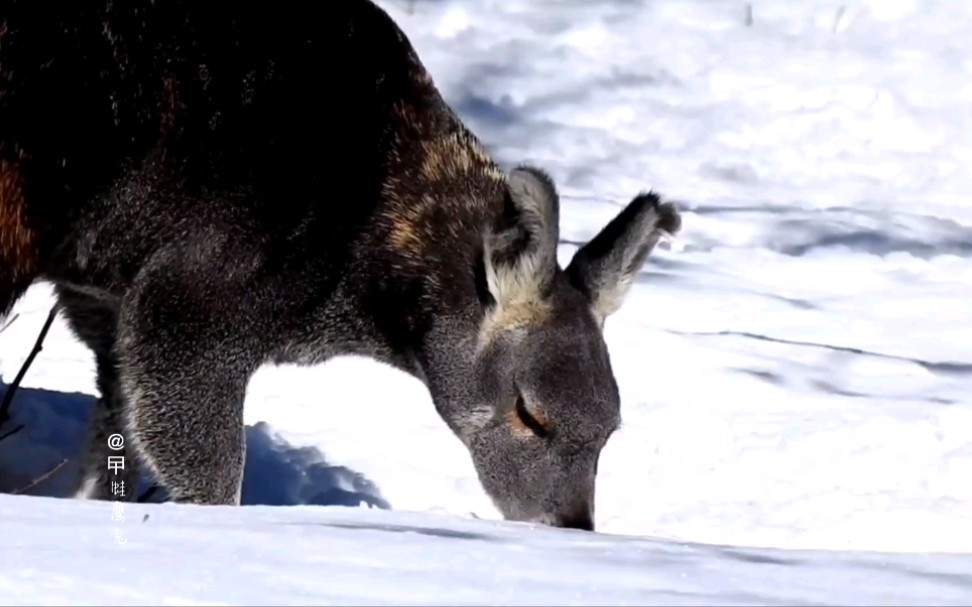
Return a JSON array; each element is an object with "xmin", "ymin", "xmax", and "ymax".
[{"xmin": 365, "ymin": 117, "xmax": 506, "ymax": 402}]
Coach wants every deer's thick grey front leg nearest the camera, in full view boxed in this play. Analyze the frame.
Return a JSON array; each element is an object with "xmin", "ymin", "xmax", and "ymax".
[{"xmin": 118, "ymin": 252, "xmax": 258, "ymax": 505}]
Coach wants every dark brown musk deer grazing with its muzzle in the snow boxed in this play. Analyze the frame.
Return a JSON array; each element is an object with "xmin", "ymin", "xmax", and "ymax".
[{"xmin": 0, "ymin": 0, "xmax": 680, "ymax": 529}]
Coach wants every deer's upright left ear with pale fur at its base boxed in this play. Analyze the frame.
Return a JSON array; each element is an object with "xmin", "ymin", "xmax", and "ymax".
[{"xmin": 484, "ymin": 166, "xmax": 560, "ymax": 307}]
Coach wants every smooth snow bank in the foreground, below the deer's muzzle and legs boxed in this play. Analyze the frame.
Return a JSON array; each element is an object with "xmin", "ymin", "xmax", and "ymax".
[{"xmin": 0, "ymin": 498, "xmax": 972, "ymax": 606}]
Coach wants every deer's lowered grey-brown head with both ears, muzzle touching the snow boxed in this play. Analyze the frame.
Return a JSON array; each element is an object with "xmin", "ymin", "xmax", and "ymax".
[{"xmin": 426, "ymin": 167, "xmax": 681, "ymax": 530}]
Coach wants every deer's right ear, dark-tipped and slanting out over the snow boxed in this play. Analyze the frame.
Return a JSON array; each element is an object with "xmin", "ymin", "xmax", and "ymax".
[{"xmin": 566, "ymin": 192, "xmax": 682, "ymax": 326}]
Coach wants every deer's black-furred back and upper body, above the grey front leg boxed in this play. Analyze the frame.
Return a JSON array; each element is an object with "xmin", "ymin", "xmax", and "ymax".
[{"xmin": 0, "ymin": 0, "xmax": 446, "ymax": 314}]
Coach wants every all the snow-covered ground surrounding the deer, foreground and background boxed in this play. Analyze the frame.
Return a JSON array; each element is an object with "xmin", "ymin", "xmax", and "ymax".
[{"xmin": 0, "ymin": 0, "xmax": 972, "ymax": 604}]
